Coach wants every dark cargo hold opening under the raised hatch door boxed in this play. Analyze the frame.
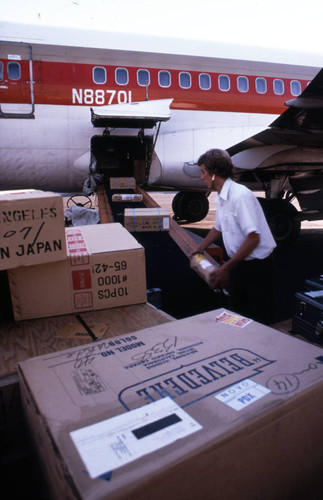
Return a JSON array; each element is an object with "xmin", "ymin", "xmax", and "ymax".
[{"xmin": 91, "ymin": 134, "xmax": 153, "ymax": 185}]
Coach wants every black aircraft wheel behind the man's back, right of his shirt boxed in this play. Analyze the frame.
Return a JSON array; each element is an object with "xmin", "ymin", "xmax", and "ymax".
[{"xmin": 258, "ymin": 198, "xmax": 301, "ymax": 246}]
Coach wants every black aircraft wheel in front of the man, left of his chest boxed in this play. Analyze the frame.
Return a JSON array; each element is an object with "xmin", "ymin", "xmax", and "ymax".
[{"xmin": 172, "ymin": 191, "xmax": 209, "ymax": 222}]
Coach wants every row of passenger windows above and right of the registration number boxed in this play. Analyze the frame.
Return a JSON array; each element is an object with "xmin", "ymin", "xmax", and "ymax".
[{"xmin": 93, "ymin": 66, "xmax": 301, "ymax": 96}]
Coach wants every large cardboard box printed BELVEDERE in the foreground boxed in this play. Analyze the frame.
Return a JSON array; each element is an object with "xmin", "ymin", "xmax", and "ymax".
[{"xmin": 19, "ymin": 309, "xmax": 323, "ymax": 500}]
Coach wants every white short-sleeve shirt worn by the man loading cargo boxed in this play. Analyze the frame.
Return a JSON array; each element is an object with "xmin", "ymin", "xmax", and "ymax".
[{"xmin": 214, "ymin": 179, "xmax": 276, "ymax": 260}]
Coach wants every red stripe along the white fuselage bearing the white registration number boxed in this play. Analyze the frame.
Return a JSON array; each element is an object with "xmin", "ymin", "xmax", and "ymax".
[{"xmin": 0, "ymin": 60, "xmax": 308, "ymax": 114}]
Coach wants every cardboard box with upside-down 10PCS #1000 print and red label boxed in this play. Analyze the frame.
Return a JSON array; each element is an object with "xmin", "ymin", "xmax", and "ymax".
[{"xmin": 8, "ymin": 223, "xmax": 147, "ymax": 321}]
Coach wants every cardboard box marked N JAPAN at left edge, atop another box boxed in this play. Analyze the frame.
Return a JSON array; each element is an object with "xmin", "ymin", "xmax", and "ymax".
[{"xmin": 0, "ymin": 189, "xmax": 66, "ymax": 270}]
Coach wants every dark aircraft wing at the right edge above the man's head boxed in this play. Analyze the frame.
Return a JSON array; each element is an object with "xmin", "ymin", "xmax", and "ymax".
[{"xmin": 227, "ymin": 65, "xmax": 323, "ymax": 157}]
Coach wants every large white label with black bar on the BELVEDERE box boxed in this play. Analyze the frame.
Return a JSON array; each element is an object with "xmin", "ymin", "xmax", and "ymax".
[{"xmin": 70, "ymin": 397, "xmax": 202, "ymax": 478}]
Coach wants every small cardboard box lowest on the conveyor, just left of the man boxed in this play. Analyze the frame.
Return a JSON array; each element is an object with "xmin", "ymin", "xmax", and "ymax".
[{"xmin": 124, "ymin": 207, "xmax": 169, "ymax": 232}]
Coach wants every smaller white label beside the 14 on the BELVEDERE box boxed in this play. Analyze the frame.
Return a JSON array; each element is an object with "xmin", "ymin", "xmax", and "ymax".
[{"xmin": 214, "ymin": 379, "xmax": 271, "ymax": 411}]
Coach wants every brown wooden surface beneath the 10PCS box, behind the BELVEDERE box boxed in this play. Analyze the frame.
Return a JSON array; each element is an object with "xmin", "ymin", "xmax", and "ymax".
[{"xmin": 0, "ymin": 303, "xmax": 174, "ymax": 377}]
